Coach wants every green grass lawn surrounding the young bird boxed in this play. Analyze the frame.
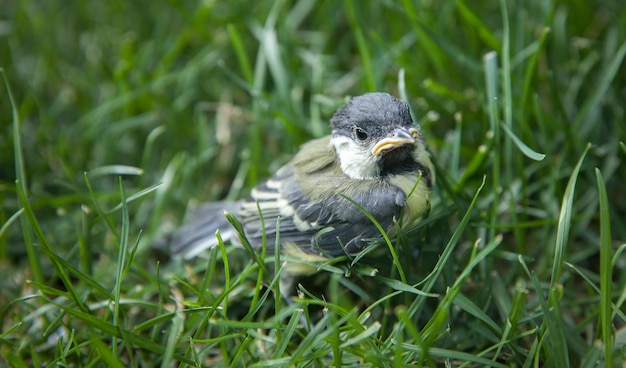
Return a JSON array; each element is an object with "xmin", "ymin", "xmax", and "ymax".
[{"xmin": 0, "ymin": 0, "xmax": 626, "ymax": 367}]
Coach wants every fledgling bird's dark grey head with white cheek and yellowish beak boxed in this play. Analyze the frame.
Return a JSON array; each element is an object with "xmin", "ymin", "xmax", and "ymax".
[{"xmin": 331, "ymin": 93, "xmax": 428, "ymax": 179}]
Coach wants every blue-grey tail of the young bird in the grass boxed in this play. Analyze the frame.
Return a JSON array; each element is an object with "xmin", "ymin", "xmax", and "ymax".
[{"xmin": 170, "ymin": 201, "xmax": 239, "ymax": 259}]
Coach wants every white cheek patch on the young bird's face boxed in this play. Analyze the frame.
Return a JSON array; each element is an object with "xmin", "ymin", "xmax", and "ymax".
[{"xmin": 332, "ymin": 135, "xmax": 380, "ymax": 179}]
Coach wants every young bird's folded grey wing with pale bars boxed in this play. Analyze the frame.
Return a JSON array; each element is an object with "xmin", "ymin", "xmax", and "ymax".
[{"xmin": 237, "ymin": 140, "xmax": 405, "ymax": 256}]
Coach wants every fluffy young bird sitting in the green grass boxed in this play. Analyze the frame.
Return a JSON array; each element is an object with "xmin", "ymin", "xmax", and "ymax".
[{"xmin": 171, "ymin": 92, "xmax": 435, "ymax": 282}]
